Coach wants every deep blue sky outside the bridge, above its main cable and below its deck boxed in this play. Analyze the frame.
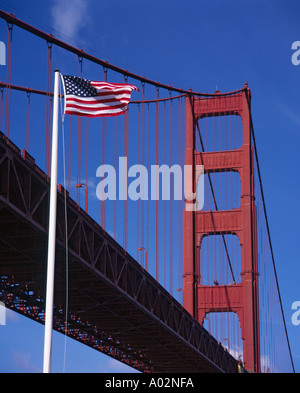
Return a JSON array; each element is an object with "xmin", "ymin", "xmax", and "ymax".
[{"xmin": 0, "ymin": 0, "xmax": 300, "ymax": 372}]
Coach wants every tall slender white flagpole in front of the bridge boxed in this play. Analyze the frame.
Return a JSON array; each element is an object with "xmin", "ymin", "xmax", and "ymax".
[{"xmin": 43, "ymin": 70, "xmax": 60, "ymax": 373}]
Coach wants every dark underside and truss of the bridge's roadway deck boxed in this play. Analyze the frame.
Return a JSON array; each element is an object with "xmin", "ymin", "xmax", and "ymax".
[{"xmin": 0, "ymin": 133, "xmax": 237, "ymax": 373}]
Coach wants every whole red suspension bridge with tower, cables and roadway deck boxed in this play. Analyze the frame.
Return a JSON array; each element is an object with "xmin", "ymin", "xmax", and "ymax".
[{"xmin": 0, "ymin": 11, "xmax": 294, "ymax": 373}]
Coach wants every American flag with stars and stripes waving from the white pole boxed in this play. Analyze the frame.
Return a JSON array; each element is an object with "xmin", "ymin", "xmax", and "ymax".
[{"xmin": 62, "ymin": 75, "xmax": 139, "ymax": 117}]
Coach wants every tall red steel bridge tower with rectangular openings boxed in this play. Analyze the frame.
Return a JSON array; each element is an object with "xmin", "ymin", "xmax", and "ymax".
[{"xmin": 184, "ymin": 85, "xmax": 260, "ymax": 372}]
